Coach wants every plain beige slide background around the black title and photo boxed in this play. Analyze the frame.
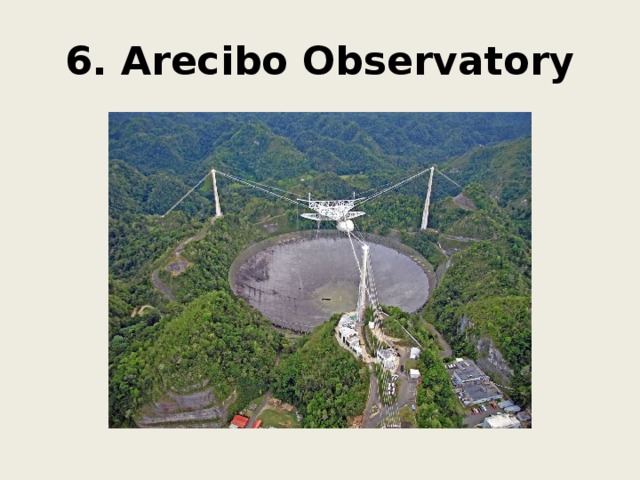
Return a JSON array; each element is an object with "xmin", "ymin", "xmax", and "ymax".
[{"xmin": 0, "ymin": 0, "xmax": 639, "ymax": 479}]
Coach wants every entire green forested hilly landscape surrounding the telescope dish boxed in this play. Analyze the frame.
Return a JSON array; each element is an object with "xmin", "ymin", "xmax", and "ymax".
[{"xmin": 109, "ymin": 113, "xmax": 531, "ymax": 426}]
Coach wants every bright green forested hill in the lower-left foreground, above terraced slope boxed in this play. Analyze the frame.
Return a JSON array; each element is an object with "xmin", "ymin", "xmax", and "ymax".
[{"xmin": 109, "ymin": 292, "xmax": 282, "ymax": 426}]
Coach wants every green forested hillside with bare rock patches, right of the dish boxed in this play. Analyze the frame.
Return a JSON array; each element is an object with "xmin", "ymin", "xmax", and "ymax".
[{"xmin": 425, "ymin": 184, "xmax": 531, "ymax": 404}]
